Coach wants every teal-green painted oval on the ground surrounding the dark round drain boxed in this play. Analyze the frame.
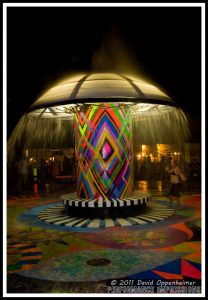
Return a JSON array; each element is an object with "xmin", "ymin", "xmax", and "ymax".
[{"xmin": 18, "ymin": 249, "xmax": 184, "ymax": 282}]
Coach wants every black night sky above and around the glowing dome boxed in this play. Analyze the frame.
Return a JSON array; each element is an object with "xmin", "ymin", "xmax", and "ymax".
[{"xmin": 7, "ymin": 6, "xmax": 201, "ymax": 142}]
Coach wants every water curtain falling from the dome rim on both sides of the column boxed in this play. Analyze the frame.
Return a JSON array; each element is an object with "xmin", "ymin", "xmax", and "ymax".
[{"xmin": 7, "ymin": 103, "xmax": 190, "ymax": 168}]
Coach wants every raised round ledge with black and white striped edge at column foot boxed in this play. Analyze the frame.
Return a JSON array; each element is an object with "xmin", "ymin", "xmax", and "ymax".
[{"xmin": 61, "ymin": 192, "xmax": 151, "ymax": 208}]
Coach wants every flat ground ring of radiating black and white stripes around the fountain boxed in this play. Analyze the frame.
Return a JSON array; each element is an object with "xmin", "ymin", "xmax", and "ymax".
[{"xmin": 38, "ymin": 204, "xmax": 174, "ymax": 229}]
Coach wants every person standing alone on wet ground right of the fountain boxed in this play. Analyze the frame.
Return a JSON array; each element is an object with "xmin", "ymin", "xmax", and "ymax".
[{"xmin": 167, "ymin": 158, "xmax": 185, "ymax": 209}]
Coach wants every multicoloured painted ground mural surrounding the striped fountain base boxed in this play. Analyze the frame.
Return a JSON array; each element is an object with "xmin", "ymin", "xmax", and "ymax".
[{"xmin": 7, "ymin": 189, "xmax": 201, "ymax": 293}]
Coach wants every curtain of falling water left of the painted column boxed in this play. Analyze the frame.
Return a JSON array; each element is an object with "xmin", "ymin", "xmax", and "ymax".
[{"xmin": 7, "ymin": 114, "xmax": 74, "ymax": 164}]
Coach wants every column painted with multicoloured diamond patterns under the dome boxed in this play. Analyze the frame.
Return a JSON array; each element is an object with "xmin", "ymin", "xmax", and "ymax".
[{"xmin": 75, "ymin": 103, "xmax": 134, "ymax": 199}]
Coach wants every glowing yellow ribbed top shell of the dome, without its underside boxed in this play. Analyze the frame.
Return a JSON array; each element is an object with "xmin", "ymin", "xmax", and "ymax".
[{"xmin": 29, "ymin": 73, "xmax": 176, "ymax": 108}]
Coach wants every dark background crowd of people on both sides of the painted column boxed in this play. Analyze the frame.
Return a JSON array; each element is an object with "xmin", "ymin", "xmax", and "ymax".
[{"xmin": 10, "ymin": 152, "xmax": 201, "ymax": 195}]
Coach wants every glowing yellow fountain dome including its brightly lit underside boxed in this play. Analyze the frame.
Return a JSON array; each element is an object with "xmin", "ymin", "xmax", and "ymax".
[{"xmin": 29, "ymin": 73, "xmax": 177, "ymax": 118}]
